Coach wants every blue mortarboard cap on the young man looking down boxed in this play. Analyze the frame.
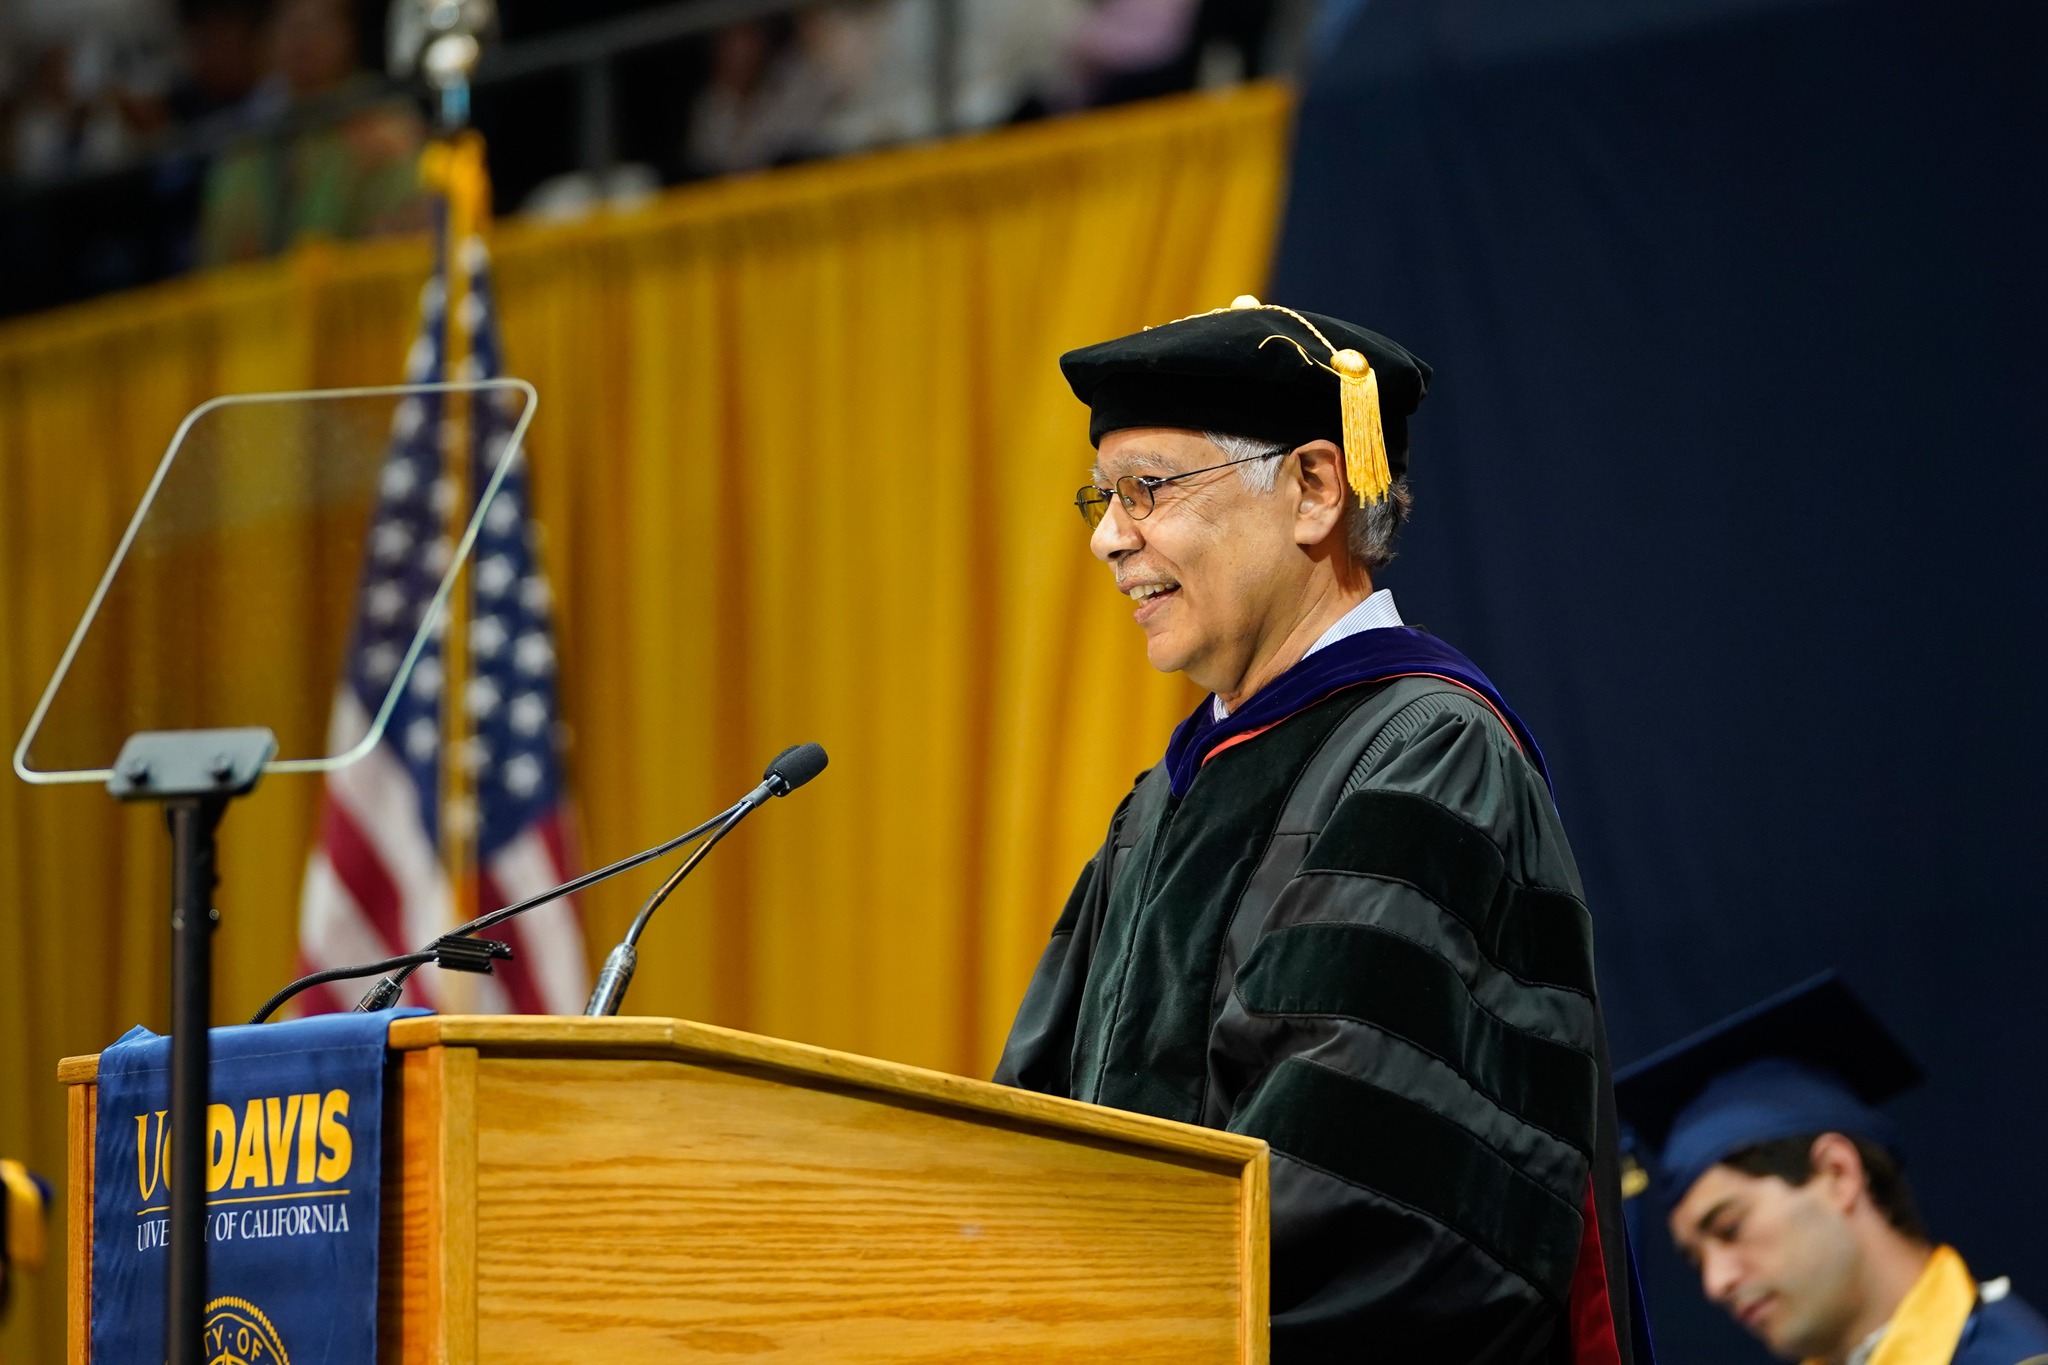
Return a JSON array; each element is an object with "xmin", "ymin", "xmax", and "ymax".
[{"xmin": 1614, "ymin": 972, "xmax": 1921, "ymax": 1207}]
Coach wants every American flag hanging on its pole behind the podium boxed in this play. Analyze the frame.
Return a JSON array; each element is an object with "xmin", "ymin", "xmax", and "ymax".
[{"xmin": 299, "ymin": 227, "xmax": 590, "ymax": 1015}]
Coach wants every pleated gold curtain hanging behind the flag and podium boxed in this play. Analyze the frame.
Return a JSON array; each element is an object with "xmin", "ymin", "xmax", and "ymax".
[{"xmin": 0, "ymin": 86, "xmax": 1290, "ymax": 1361}]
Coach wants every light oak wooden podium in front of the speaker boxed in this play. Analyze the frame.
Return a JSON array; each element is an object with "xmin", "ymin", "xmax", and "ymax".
[{"xmin": 57, "ymin": 1015, "xmax": 1268, "ymax": 1365}]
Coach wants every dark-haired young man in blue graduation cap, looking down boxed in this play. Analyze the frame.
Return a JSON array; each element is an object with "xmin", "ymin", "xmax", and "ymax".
[{"xmin": 1616, "ymin": 972, "xmax": 2048, "ymax": 1365}]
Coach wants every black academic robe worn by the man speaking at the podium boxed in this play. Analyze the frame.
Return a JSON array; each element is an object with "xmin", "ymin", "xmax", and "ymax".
[{"xmin": 995, "ymin": 677, "xmax": 1636, "ymax": 1365}]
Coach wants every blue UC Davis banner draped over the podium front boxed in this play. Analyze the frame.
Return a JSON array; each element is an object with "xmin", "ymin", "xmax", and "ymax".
[{"xmin": 92, "ymin": 1009, "xmax": 426, "ymax": 1365}]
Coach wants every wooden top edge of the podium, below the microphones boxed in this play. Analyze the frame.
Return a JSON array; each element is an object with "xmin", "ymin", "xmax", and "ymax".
[{"xmin": 57, "ymin": 1015, "xmax": 1266, "ymax": 1171}]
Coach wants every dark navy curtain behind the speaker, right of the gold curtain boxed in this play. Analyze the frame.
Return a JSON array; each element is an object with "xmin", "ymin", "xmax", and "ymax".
[{"xmin": 1272, "ymin": 0, "xmax": 2048, "ymax": 1365}]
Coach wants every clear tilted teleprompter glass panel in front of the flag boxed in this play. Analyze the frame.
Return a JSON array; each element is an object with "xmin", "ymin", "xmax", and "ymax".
[{"xmin": 14, "ymin": 379, "xmax": 535, "ymax": 782}]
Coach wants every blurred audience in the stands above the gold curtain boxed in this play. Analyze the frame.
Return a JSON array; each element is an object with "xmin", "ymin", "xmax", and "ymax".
[{"xmin": 0, "ymin": 0, "xmax": 1321, "ymax": 315}]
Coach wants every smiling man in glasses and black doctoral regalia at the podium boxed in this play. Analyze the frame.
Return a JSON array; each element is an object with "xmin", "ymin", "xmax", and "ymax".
[{"xmin": 997, "ymin": 297, "xmax": 1649, "ymax": 1365}]
